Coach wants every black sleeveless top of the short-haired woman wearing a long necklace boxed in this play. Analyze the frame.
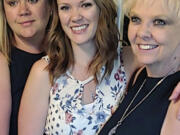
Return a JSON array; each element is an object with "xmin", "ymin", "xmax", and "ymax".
[{"xmin": 99, "ymin": 69, "xmax": 180, "ymax": 135}]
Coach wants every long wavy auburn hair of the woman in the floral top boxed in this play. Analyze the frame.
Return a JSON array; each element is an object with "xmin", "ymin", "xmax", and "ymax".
[{"xmin": 47, "ymin": 0, "xmax": 120, "ymax": 84}]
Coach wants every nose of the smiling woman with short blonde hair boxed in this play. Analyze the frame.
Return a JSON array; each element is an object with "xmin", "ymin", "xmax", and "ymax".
[{"xmin": 137, "ymin": 23, "xmax": 152, "ymax": 41}]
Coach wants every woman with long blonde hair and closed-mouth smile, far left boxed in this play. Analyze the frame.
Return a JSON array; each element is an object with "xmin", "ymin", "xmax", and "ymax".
[{"xmin": 0, "ymin": 0, "xmax": 57, "ymax": 135}]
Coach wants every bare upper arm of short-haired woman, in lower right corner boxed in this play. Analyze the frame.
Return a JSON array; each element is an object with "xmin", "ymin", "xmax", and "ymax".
[{"xmin": 161, "ymin": 101, "xmax": 180, "ymax": 135}]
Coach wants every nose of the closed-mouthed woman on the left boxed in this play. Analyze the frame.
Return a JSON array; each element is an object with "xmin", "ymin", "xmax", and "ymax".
[{"xmin": 19, "ymin": 0, "xmax": 30, "ymax": 16}]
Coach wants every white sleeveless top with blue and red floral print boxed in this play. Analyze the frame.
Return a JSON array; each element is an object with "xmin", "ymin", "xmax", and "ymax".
[{"xmin": 45, "ymin": 46, "xmax": 126, "ymax": 135}]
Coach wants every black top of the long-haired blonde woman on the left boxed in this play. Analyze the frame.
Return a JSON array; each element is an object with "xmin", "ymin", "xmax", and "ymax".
[{"xmin": 9, "ymin": 47, "xmax": 45, "ymax": 135}]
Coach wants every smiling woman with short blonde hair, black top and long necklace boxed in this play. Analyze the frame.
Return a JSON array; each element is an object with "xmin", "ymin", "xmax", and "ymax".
[{"xmin": 100, "ymin": 0, "xmax": 180, "ymax": 135}]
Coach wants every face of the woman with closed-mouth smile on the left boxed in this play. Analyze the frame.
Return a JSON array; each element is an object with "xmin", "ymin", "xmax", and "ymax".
[{"xmin": 4, "ymin": 0, "xmax": 50, "ymax": 39}]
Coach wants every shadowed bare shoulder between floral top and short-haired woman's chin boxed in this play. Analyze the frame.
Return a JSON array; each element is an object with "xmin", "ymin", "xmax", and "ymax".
[{"xmin": 122, "ymin": 46, "xmax": 141, "ymax": 80}]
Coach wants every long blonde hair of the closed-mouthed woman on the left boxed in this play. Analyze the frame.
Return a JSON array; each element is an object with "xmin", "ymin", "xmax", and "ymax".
[{"xmin": 0, "ymin": 0, "xmax": 58, "ymax": 61}]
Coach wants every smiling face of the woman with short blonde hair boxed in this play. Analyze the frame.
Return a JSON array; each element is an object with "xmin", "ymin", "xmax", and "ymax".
[{"xmin": 128, "ymin": 0, "xmax": 180, "ymax": 65}]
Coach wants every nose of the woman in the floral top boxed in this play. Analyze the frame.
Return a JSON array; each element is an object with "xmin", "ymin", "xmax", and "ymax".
[{"xmin": 71, "ymin": 9, "xmax": 83, "ymax": 22}]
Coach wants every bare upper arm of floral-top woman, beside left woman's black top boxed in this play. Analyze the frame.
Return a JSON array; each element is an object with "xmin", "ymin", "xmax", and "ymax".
[{"xmin": 18, "ymin": 59, "xmax": 50, "ymax": 135}]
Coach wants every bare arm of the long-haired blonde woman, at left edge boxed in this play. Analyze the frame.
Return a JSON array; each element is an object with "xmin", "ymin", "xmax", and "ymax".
[{"xmin": 0, "ymin": 53, "xmax": 11, "ymax": 135}]
